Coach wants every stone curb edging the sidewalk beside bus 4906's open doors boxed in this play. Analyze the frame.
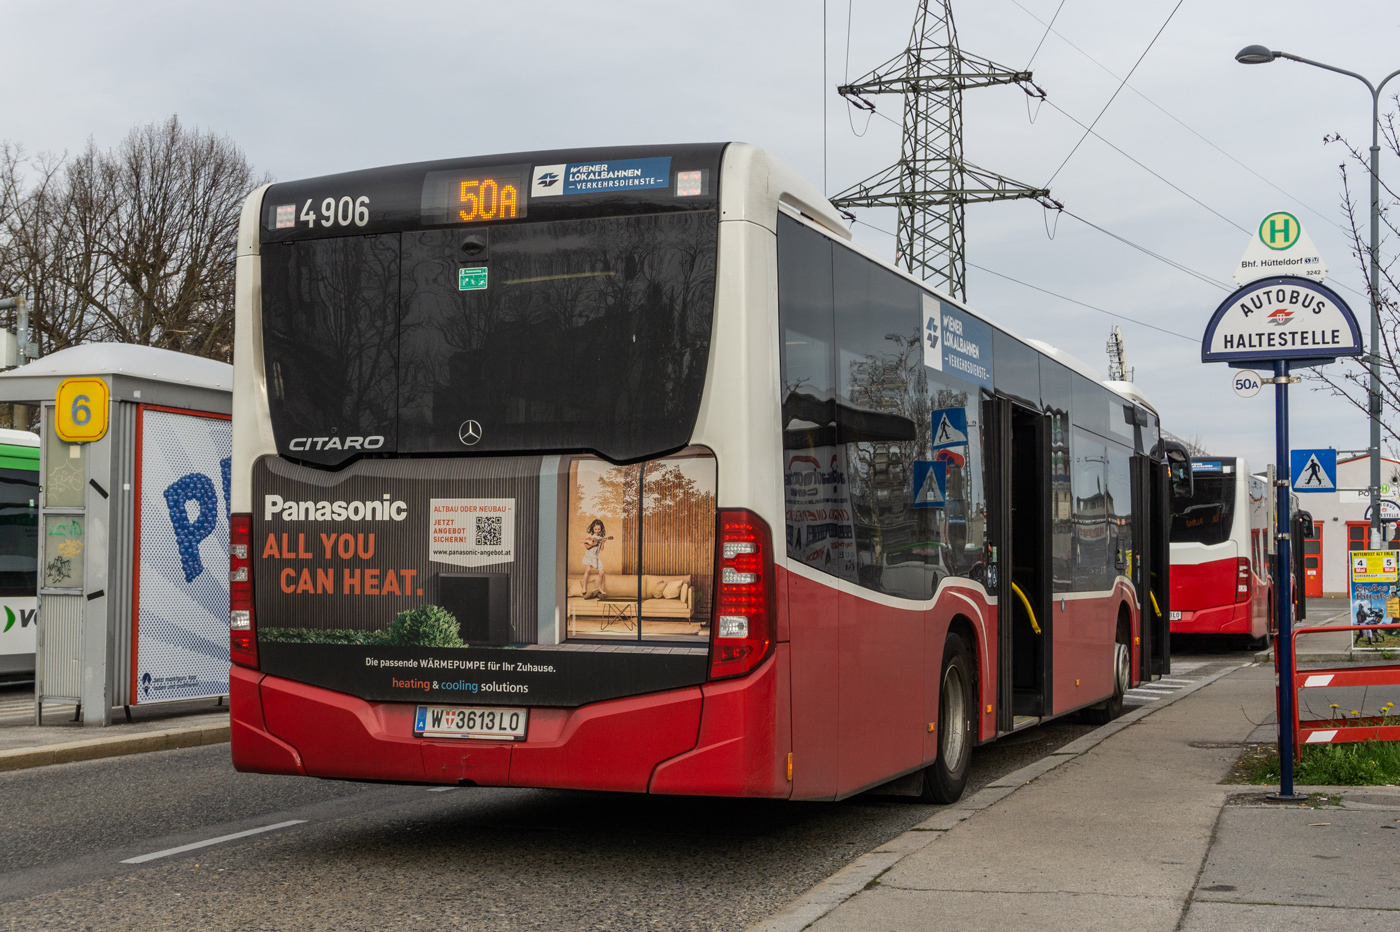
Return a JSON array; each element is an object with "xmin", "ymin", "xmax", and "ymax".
[{"xmin": 746, "ymin": 663, "xmax": 1250, "ymax": 932}]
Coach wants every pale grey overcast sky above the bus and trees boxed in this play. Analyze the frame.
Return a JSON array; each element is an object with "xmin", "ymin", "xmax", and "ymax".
[{"xmin": 0, "ymin": 0, "xmax": 1400, "ymax": 467}]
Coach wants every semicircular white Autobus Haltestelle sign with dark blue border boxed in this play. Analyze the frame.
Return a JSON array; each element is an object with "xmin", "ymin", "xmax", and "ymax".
[{"xmin": 1201, "ymin": 276, "xmax": 1362, "ymax": 362}]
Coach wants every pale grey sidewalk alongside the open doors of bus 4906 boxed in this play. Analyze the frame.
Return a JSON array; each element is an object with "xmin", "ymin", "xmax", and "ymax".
[{"xmin": 755, "ymin": 666, "xmax": 1400, "ymax": 932}]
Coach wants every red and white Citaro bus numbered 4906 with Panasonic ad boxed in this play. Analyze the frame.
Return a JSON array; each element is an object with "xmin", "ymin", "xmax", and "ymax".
[{"xmin": 230, "ymin": 143, "xmax": 1168, "ymax": 800}]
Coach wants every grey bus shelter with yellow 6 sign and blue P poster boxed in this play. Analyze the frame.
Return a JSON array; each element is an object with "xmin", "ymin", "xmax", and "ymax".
[{"xmin": 0, "ymin": 343, "xmax": 232, "ymax": 725}]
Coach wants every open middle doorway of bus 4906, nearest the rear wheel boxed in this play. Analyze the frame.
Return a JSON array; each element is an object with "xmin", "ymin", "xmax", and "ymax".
[{"xmin": 983, "ymin": 396, "xmax": 1053, "ymax": 732}]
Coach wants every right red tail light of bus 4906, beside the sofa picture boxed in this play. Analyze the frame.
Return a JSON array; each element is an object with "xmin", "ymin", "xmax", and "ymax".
[{"xmin": 710, "ymin": 511, "xmax": 774, "ymax": 680}]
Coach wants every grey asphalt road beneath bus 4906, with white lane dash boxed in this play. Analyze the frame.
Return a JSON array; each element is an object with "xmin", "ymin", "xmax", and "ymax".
[{"xmin": 0, "ymin": 652, "xmax": 1247, "ymax": 932}]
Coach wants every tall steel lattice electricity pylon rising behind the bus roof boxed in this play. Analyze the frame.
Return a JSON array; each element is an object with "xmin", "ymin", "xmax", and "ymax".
[{"xmin": 832, "ymin": 0, "xmax": 1060, "ymax": 298}]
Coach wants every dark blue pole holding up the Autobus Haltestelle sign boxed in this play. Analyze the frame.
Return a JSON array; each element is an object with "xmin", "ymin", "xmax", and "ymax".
[{"xmin": 1270, "ymin": 360, "xmax": 1306, "ymax": 802}]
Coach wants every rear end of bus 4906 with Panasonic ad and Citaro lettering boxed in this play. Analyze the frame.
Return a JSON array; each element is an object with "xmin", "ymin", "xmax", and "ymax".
[{"xmin": 231, "ymin": 144, "xmax": 820, "ymax": 796}]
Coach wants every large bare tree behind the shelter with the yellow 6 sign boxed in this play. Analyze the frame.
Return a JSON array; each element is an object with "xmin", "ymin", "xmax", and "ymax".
[{"xmin": 0, "ymin": 116, "xmax": 267, "ymax": 360}]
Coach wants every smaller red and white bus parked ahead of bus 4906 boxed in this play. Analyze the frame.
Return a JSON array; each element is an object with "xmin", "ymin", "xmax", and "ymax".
[{"xmin": 1172, "ymin": 456, "xmax": 1274, "ymax": 647}]
